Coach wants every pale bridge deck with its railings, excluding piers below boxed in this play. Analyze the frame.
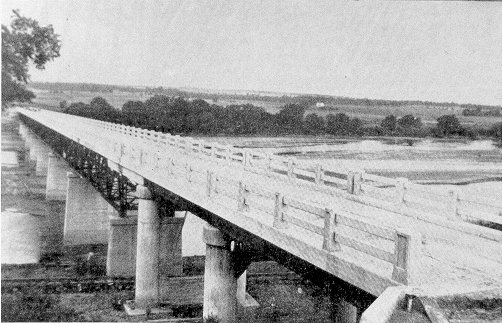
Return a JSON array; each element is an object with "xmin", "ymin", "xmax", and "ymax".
[{"xmin": 20, "ymin": 110, "xmax": 502, "ymax": 296}]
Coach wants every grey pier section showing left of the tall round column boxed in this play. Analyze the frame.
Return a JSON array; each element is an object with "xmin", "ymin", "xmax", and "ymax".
[{"xmin": 106, "ymin": 215, "xmax": 138, "ymax": 277}]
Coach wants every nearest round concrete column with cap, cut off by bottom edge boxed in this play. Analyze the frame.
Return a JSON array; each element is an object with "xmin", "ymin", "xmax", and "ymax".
[{"xmin": 203, "ymin": 224, "xmax": 237, "ymax": 323}]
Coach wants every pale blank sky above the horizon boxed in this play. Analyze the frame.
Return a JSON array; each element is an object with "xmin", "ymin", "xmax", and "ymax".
[{"xmin": 1, "ymin": 0, "xmax": 502, "ymax": 105}]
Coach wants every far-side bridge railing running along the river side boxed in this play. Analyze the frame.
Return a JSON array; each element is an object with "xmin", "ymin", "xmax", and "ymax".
[{"xmin": 22, "ymin": 112, "xmax": 502, "ymax": 233}]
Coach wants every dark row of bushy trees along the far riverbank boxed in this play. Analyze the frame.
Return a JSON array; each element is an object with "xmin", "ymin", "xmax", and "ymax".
[{"xmin": 60, "ymin": 95, "xmax": 502, "ymax": 142}]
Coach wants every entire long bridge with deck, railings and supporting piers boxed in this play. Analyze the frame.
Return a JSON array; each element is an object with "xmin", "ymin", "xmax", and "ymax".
[{"xmin": 12, "ymin": 109, "xmax": 502, "ymax": 322}]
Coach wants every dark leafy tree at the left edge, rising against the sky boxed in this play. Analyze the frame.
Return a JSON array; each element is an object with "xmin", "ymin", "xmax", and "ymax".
[{"xmin": 2, "ymin": 10, "xmax": 61, "ymax": 104}]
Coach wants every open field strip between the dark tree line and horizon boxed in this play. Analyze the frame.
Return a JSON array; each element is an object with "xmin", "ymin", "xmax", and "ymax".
[{"xmin": 28, "ymin": 90, "xmax": 502, "ymax": 128}]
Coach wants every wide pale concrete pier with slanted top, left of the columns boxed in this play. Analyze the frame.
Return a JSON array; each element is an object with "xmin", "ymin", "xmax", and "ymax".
[{"xmin": 63, "ymin": 172, "xmax": 117, "ymax": 245}]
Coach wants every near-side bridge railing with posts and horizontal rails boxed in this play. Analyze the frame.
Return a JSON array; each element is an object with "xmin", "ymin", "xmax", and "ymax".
[{"xmin": 20, "ymin": 108, "xmax": 428, "ymax": 284}]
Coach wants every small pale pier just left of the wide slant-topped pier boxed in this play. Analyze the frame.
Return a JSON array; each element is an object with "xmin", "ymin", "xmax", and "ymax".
[{"xmin": 45, "ymin": 153, "xmax": 70, "ymax": 201}]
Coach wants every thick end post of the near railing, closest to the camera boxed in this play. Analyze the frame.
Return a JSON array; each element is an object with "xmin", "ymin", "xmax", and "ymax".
[{"xmin": 392, "ymin": 228, "xmax": 422, "ymax": 285}]
